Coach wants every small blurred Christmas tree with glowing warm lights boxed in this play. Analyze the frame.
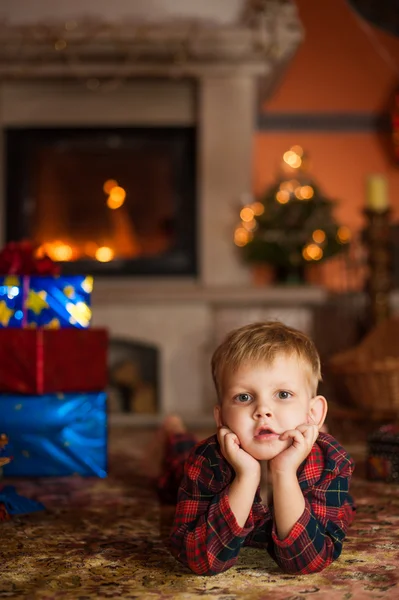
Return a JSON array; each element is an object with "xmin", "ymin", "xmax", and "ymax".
[{"xmin": 234, "ymin": 146, "xmax": 350, "ymax": 280}]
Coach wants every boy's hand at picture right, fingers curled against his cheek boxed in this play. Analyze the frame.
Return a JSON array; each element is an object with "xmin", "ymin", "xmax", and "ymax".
[{"xmin": 270, "ymin": 423, "xmax": 319, "ymax": 475}]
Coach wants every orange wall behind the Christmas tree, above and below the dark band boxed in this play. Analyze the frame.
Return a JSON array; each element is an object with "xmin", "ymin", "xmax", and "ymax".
[{"xmin": 254, "ymin": 0, "xmax": 399, "ymax": 229}]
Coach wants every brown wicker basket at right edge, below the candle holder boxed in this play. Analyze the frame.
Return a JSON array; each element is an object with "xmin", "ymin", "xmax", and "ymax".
[{"xmin": 329, "ymin": 319, "xmax": 399, "ymax": 413}]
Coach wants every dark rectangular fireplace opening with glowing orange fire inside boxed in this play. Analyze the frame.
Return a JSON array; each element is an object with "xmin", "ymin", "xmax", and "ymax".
[{"xmin": 5, "ymin": 127, "xmax": 197, "ymax": 276}]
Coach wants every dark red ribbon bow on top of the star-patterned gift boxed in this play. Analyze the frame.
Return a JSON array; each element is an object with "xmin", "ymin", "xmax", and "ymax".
[{"xmin": 0, "ymin": 241, "xmax": 60, "ymax": 275}]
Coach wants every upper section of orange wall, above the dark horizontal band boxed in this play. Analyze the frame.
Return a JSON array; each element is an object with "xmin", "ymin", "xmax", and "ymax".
[{"xmin": 265, "ymin": 0, "xmax": 399, "ymax": 112}]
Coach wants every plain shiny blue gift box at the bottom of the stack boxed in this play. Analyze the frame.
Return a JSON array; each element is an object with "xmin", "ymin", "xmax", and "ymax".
[{"xmin": 0, "ymin": 392, "xmax": 107, "ymax": 477}]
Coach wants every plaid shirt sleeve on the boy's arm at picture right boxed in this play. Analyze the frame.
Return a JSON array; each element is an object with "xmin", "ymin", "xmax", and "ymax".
[{"xmin": 272, "ymin": 442, "xmax": 354, "ymax": 574}]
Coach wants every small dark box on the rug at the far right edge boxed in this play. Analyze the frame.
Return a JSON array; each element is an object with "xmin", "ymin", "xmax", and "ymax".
[{"xmin": 366, "ymin": 425, "xmax": 399, "ymax": 483}]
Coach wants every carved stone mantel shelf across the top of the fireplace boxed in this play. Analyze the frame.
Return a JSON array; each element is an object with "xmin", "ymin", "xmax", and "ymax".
[{"xmin": 0, "ymin": 0, "xmax": 303, "ymax": 90}]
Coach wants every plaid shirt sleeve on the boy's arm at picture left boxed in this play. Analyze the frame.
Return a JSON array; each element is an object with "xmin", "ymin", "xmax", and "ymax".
[{"xmin": 171, "ymin": 440, "xmax": 254, "ymax": 575}]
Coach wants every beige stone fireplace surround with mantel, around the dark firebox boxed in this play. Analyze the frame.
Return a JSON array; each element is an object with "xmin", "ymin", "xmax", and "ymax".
[{"xmin": 0, "ymin": 0, "xmax": 304, "ymax": 425}]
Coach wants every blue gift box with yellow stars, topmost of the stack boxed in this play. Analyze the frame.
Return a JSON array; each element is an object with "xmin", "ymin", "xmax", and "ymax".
[{"xmin": 0, "ymin": 275, "xmax": 93, "ymax": 329}]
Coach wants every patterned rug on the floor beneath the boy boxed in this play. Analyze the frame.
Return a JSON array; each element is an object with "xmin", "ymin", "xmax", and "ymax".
[{"xmin": 0, "ymin": 429, "xmax": 399, "ymax": 600}]
